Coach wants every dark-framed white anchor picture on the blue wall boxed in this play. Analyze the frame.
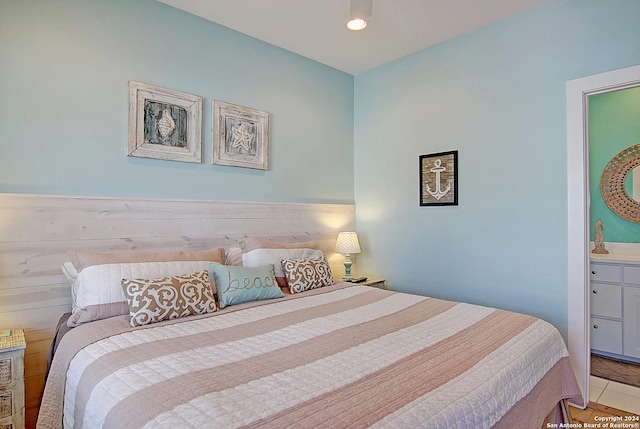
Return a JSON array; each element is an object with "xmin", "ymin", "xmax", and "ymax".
[{"xmin": 420, "ymin": 150, "xmax": 458, "ymax": 206}]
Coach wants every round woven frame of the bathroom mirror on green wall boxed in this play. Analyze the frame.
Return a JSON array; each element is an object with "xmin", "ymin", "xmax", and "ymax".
[{"xmin": 600, "ymin": 143, "xmax": 640, "ymax": 223}]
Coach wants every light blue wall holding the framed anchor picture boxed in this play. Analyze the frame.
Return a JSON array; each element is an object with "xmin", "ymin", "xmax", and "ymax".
[{"xmin": 355, "ymin": 0, "xmax": 640, "ymax": 335}]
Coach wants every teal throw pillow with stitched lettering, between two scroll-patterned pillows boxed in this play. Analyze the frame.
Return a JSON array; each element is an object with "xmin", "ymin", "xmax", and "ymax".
[{"xmin": 210, "ymin": 263, "xmax": 284, "ymax": 308}]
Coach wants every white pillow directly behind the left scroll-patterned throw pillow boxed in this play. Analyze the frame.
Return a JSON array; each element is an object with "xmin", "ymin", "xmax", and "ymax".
[{"xmin": 67, "ymin": 261, "xmax": 215, "ymax": 326}]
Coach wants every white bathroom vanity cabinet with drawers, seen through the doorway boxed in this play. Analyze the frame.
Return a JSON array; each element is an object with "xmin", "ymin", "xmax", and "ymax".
[{"xmin": 590, "ymin": 257, "xmax": 640, "ymax": 361}]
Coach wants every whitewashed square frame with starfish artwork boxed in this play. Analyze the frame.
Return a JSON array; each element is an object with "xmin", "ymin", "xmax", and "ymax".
[{"xmin": 213, "ymin": 100, "xmax": 269, "ymax": 170}]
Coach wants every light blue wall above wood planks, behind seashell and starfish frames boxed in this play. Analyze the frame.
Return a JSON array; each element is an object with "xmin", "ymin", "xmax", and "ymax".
[{"xmin": 0, "ymin": 0, "xmax": 353, "ymax": 203}]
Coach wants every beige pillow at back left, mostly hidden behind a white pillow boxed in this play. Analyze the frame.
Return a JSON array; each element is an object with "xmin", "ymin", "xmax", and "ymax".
[{"xmin": 68, "ymin": 247, "xmax": 225, "ymax": 272}]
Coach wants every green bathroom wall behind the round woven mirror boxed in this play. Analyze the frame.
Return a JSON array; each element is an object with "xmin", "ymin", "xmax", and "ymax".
[{"xmin": 589, "ymin": 87, "xmax": 640, "ymax": 243}]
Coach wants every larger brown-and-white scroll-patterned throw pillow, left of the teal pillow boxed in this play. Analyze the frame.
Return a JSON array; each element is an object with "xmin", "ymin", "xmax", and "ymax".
[{"xmin": 122, "ymin": 271, "xmax": 216, "ymax": 327}]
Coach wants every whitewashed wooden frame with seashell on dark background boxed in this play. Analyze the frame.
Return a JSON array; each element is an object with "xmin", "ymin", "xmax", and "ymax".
[{"xmin": 127, "ymin": 81, "xmax": 202, "ymax": 163}]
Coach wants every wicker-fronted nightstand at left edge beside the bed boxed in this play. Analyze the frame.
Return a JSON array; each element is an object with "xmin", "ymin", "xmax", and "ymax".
[{"xmin": 0, "ymin": 329, "xmax": 27, "ymax": 429}]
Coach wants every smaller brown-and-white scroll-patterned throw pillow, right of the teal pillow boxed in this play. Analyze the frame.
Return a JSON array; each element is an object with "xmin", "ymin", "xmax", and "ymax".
[{"xmin": 282, "ymin": 255, "xmax": 335, "ymax": 294}]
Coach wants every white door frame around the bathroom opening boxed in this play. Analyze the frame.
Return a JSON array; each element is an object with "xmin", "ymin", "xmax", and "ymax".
[{"xmin": 567, "ymin": 66, "xmax": 640, "ymax": 407}]
